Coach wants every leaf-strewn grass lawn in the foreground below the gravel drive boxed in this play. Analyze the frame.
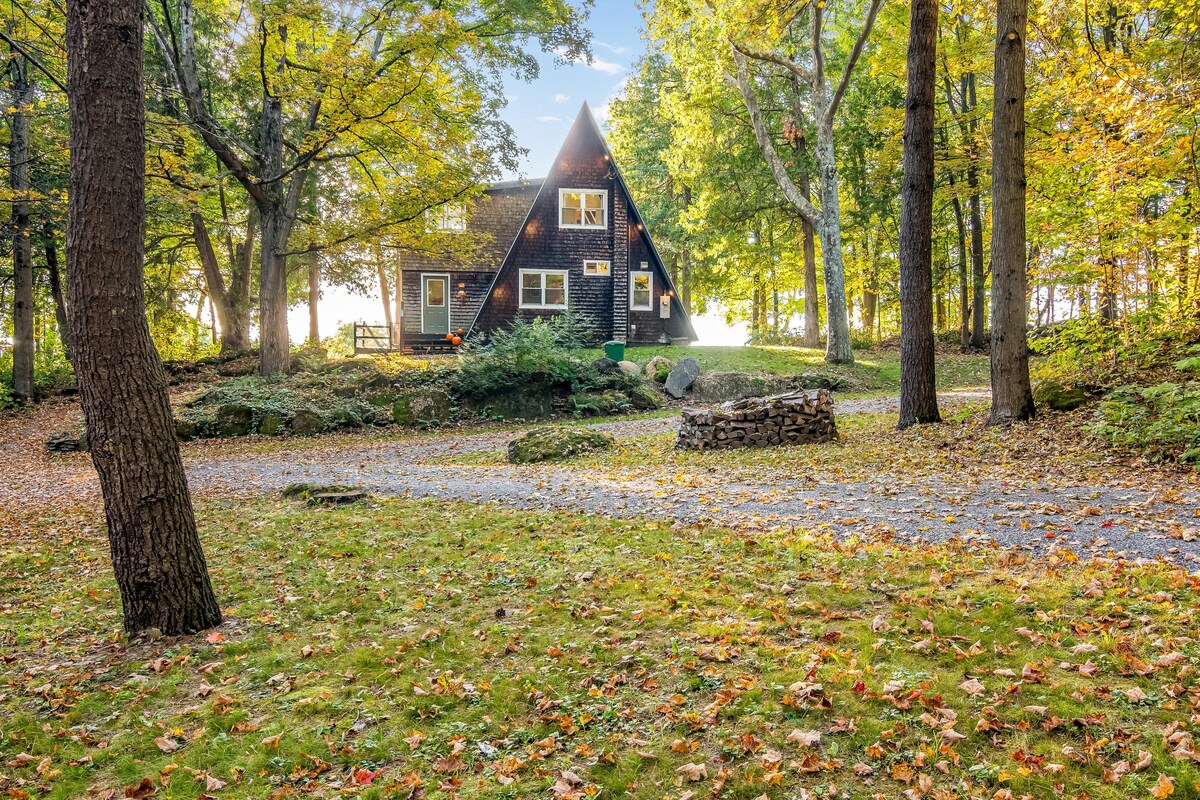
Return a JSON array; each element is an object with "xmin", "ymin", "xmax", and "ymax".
[{"xmin": 0, "ymin": 499, "xmax": 1200, "ymax": 800}]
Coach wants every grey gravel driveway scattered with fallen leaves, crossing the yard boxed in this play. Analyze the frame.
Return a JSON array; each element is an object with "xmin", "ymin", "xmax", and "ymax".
[{"xmin": 180, "ymin": 392, "xmax": 1200, "ymax": 567}]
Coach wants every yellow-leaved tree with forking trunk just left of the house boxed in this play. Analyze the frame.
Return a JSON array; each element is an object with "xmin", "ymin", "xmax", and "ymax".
[{"xmin": 151, "ymin": 0, "xmax": 587, "ymax": 374}]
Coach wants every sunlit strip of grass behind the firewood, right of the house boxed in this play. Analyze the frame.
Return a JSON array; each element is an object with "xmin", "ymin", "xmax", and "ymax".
[{"xmin": 625, "ymin": 345, "xmax": 989, "ymax": 395}]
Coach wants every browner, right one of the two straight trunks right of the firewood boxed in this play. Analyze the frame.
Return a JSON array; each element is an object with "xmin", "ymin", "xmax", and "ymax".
[{"xmin": 989, "ymin": 0, "xmax": 1033, "ymax": 425}]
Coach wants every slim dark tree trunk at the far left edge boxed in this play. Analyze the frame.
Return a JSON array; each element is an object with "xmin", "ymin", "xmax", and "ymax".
[{"xmin": 8, "ymin": 52, "xmax": 34, "ymax": 401}]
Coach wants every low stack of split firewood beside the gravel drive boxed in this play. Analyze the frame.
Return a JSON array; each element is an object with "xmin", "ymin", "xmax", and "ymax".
[{"xmin": 676, "ymin": 389, "xmax": 838, "ymax": 450}]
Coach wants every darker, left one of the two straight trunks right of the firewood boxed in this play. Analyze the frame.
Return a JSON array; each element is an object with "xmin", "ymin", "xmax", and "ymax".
[{"xmin": 900, "ymin": 0, "xmax": 942, "ymax": 428}]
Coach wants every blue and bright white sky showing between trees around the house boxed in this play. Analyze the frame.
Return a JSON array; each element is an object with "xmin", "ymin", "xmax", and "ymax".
[{"xmin": 288, "ymin": 0, "xmax": 746, "ymax": 344}]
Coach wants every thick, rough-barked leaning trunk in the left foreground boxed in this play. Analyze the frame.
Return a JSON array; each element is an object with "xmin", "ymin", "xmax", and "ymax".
[{"xmin": 67, "ymin": 0, "xmax": 221, "ymax": 634}]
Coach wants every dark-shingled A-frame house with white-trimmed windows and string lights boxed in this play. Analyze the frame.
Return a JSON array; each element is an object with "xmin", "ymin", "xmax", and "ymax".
[{"xmin": 391, "ymin": 104, "xmax": 696, "ymax": 349}]
